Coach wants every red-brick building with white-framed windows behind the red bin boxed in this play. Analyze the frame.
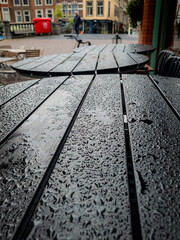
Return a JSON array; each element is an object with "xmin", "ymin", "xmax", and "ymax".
[{"xmin": 0, "ymin": 0, "xmax": 56, "ymax": 23}]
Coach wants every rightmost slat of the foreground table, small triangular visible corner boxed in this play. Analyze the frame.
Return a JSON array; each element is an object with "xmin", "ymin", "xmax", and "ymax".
[{"xmin": 153, "ymin": 75, "xmax": 180, "ymax": 114}]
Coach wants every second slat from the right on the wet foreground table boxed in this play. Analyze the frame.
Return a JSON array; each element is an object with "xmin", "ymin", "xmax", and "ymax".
[{"xmin": 122, "ymin": 75, "xmax": 180, "ymax": 240}]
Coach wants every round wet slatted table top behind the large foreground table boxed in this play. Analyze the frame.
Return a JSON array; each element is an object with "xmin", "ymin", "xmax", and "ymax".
[{"xmin": 12, "ymin": 44, "xmax": 150, "ymax": 76}]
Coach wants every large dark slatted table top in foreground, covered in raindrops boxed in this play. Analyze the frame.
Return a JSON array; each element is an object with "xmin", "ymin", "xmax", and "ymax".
[{"xmin": 0, "ymin": 74, "xmax": 180, "ymax": 240}]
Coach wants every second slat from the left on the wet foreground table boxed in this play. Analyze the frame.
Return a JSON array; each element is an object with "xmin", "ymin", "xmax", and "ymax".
[{"xmin": 0, "ymin": 77, "xmax": 65, "ymax": 142}]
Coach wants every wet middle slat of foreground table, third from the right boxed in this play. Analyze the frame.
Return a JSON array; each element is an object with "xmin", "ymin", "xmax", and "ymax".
[{"xmin": 28, "ymin": 75, "xmax": 132, "ymax": 239}]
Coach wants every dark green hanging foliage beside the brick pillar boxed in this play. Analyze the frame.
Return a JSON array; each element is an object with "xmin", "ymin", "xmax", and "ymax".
[{"xmin": 126, "ymin": 0, "xmax": 144, "ymax": 28}]
